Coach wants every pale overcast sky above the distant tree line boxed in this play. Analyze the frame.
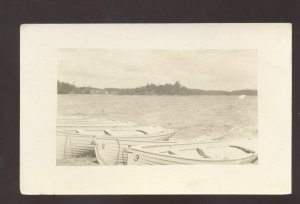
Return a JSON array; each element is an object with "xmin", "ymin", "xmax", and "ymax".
[{"xmin": 58, "ymin": 49, "xmax": 257, "ymax": 90}]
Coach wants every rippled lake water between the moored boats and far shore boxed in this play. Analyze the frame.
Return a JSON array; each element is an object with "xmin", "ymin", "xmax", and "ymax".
[{"xmin": 57, "ymin": 95, "xmax": 257, "ymax": 139}]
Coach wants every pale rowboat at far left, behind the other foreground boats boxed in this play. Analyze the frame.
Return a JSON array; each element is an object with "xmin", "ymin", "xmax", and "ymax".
[{"xmin": 56, "ymin": 126, "xmax": 175, "ymax": 158}]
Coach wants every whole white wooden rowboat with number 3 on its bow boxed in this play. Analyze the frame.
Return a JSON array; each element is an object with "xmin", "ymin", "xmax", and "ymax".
[{"xmin": 127, "ymin": 138, "xmax": 258, "ymax": 165}]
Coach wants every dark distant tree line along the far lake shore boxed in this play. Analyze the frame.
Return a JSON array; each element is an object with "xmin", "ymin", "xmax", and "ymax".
[{"xmin": 57, "ymin": 81, "xmax": 257, "ymax": 95}]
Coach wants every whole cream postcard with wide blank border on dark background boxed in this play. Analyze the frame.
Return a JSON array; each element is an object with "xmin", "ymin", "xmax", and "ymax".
[{"xmin": 20, "ymin": 23, "xmax": 292, "ymax": 195}]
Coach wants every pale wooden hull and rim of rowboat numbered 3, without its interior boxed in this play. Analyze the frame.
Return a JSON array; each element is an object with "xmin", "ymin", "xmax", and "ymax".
[{"xmin": 128, "ymin": 137, "xmax": 258, "ymax": 165}]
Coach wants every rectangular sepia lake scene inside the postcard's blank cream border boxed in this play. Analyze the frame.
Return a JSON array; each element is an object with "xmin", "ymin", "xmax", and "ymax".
[{"xmin": 56, "ymin": 48, "xmax": 259, "ymax": 166}]
